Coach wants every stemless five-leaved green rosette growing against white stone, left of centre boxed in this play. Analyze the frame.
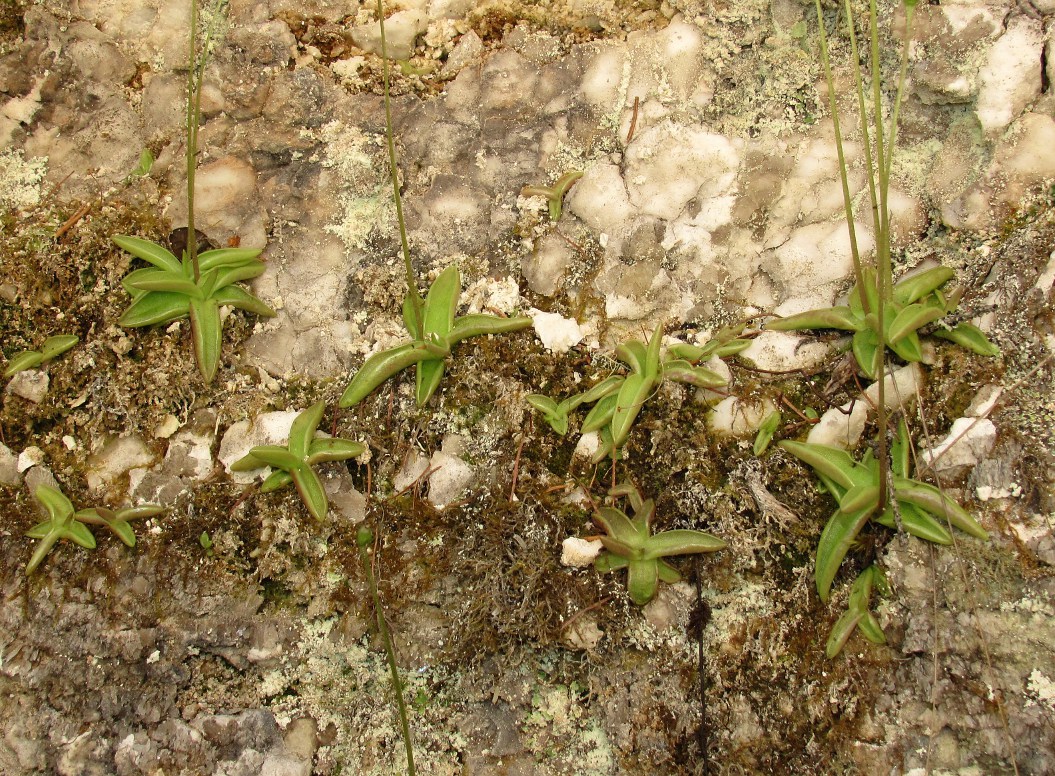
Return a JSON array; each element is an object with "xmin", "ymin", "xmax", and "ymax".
[{"xmin": 231, "ymin": 402, "xmax": 366, "ymax": 520}]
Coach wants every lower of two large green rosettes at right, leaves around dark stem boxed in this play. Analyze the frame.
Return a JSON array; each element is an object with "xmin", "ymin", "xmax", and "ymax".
[{"xmin": 776, "ymin": 421, "xmax": 989, "ymax": 601}]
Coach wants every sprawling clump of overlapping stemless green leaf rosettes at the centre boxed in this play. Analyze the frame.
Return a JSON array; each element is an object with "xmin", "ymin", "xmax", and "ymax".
[{"xmin": 528, "ymin": 323, "xmax": 751, "ymax": 463}]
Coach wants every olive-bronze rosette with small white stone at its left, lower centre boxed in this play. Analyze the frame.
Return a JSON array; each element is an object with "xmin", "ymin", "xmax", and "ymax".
[{"xmin": 594, "ymin": 483, "xmax": 726, "ymax": 606}]
